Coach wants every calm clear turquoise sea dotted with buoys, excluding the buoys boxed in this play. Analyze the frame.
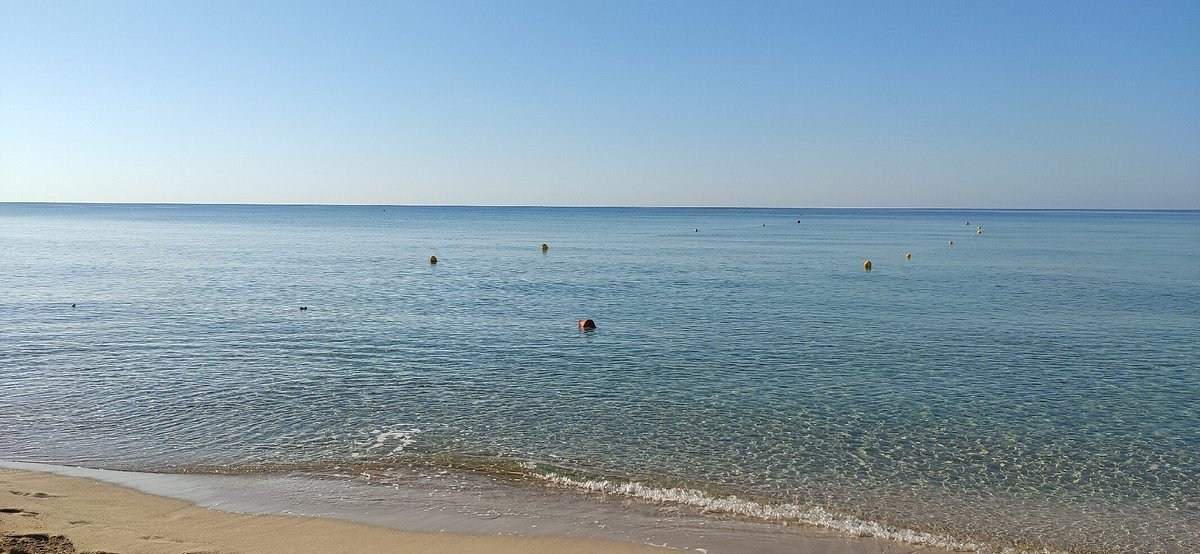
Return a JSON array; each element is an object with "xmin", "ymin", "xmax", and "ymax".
[{"xmin": 0, "ymin": 204, "xmax": 1200, "ymax": 553}]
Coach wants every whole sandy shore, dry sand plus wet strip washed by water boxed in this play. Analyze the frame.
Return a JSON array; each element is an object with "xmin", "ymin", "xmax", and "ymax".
[{"xmin": 0, "ymin": 462, "xmax": 948, "ymax": 554}]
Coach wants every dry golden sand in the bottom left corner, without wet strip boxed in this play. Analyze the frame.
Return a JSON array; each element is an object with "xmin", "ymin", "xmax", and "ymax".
[{"xmin": 0, "ymin": 469, "xmax": 664, "ymax": 554}]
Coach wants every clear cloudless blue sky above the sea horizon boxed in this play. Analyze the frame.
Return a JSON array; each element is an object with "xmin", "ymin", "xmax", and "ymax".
[{"xmin": 0, "ymin": 0, "xmax": 1200, "ymax": 209}]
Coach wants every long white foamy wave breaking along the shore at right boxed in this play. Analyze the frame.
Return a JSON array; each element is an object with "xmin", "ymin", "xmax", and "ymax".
[{"xmin": 535, "ymin": 472, "xmax": 1052, "ymax": 554}]
